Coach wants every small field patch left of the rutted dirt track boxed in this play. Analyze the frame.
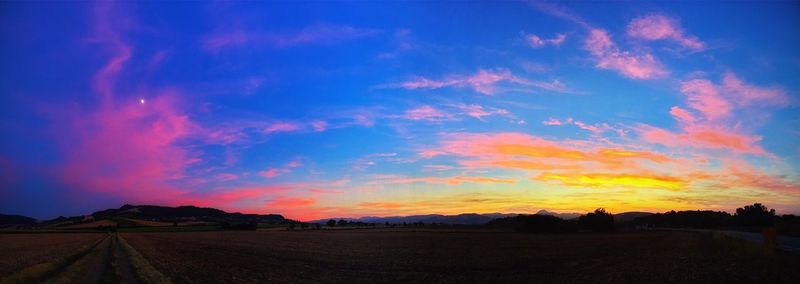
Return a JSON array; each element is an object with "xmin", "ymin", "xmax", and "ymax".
[{"xmin": 0, "ymin": 233, "xmax": 106, "ymax": 278}]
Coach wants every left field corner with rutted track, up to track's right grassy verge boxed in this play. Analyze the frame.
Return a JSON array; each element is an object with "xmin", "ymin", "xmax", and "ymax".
[{"xmin": 0, "ymin": 232, "xmax": 167, "ymax": 283}]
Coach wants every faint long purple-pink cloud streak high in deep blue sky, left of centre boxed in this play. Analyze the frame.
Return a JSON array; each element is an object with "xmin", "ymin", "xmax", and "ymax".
[{"xmin": 202, "ymin": 24, "xmax": 381, "ymax": 51}]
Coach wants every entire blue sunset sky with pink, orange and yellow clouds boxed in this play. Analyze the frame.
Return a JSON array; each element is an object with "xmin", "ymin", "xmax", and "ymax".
[{"xmin": 0, "ymin": 1, "xmax": 800, "ymax": 220}]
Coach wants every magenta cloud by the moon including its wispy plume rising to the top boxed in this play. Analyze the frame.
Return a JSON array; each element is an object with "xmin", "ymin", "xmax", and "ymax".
[{"xmin": 48, "ymin": 3, "xmax": 206, "ymax": 202}]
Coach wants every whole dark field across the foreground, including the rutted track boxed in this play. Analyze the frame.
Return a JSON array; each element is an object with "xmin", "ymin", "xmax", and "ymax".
[{"xmin": 0, "ymin": 228, "xmax": 800, "ymax": 283}]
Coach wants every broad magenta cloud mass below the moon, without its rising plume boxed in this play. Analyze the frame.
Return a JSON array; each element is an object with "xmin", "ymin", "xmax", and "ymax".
[{"xmin": 59, "ymin": 92, "xmax": 201, "ymax": 200}]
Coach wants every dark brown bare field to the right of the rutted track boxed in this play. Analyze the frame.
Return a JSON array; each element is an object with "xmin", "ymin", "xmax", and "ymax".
[{"xmin": 122, "ymin": 230, "xmax": 800, "ymax": 283}]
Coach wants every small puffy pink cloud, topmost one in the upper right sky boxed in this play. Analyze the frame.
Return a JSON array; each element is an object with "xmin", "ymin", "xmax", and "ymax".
[{"xmin": 627, "ymin": 14, "xmax": 705, "ymax": 50}]
